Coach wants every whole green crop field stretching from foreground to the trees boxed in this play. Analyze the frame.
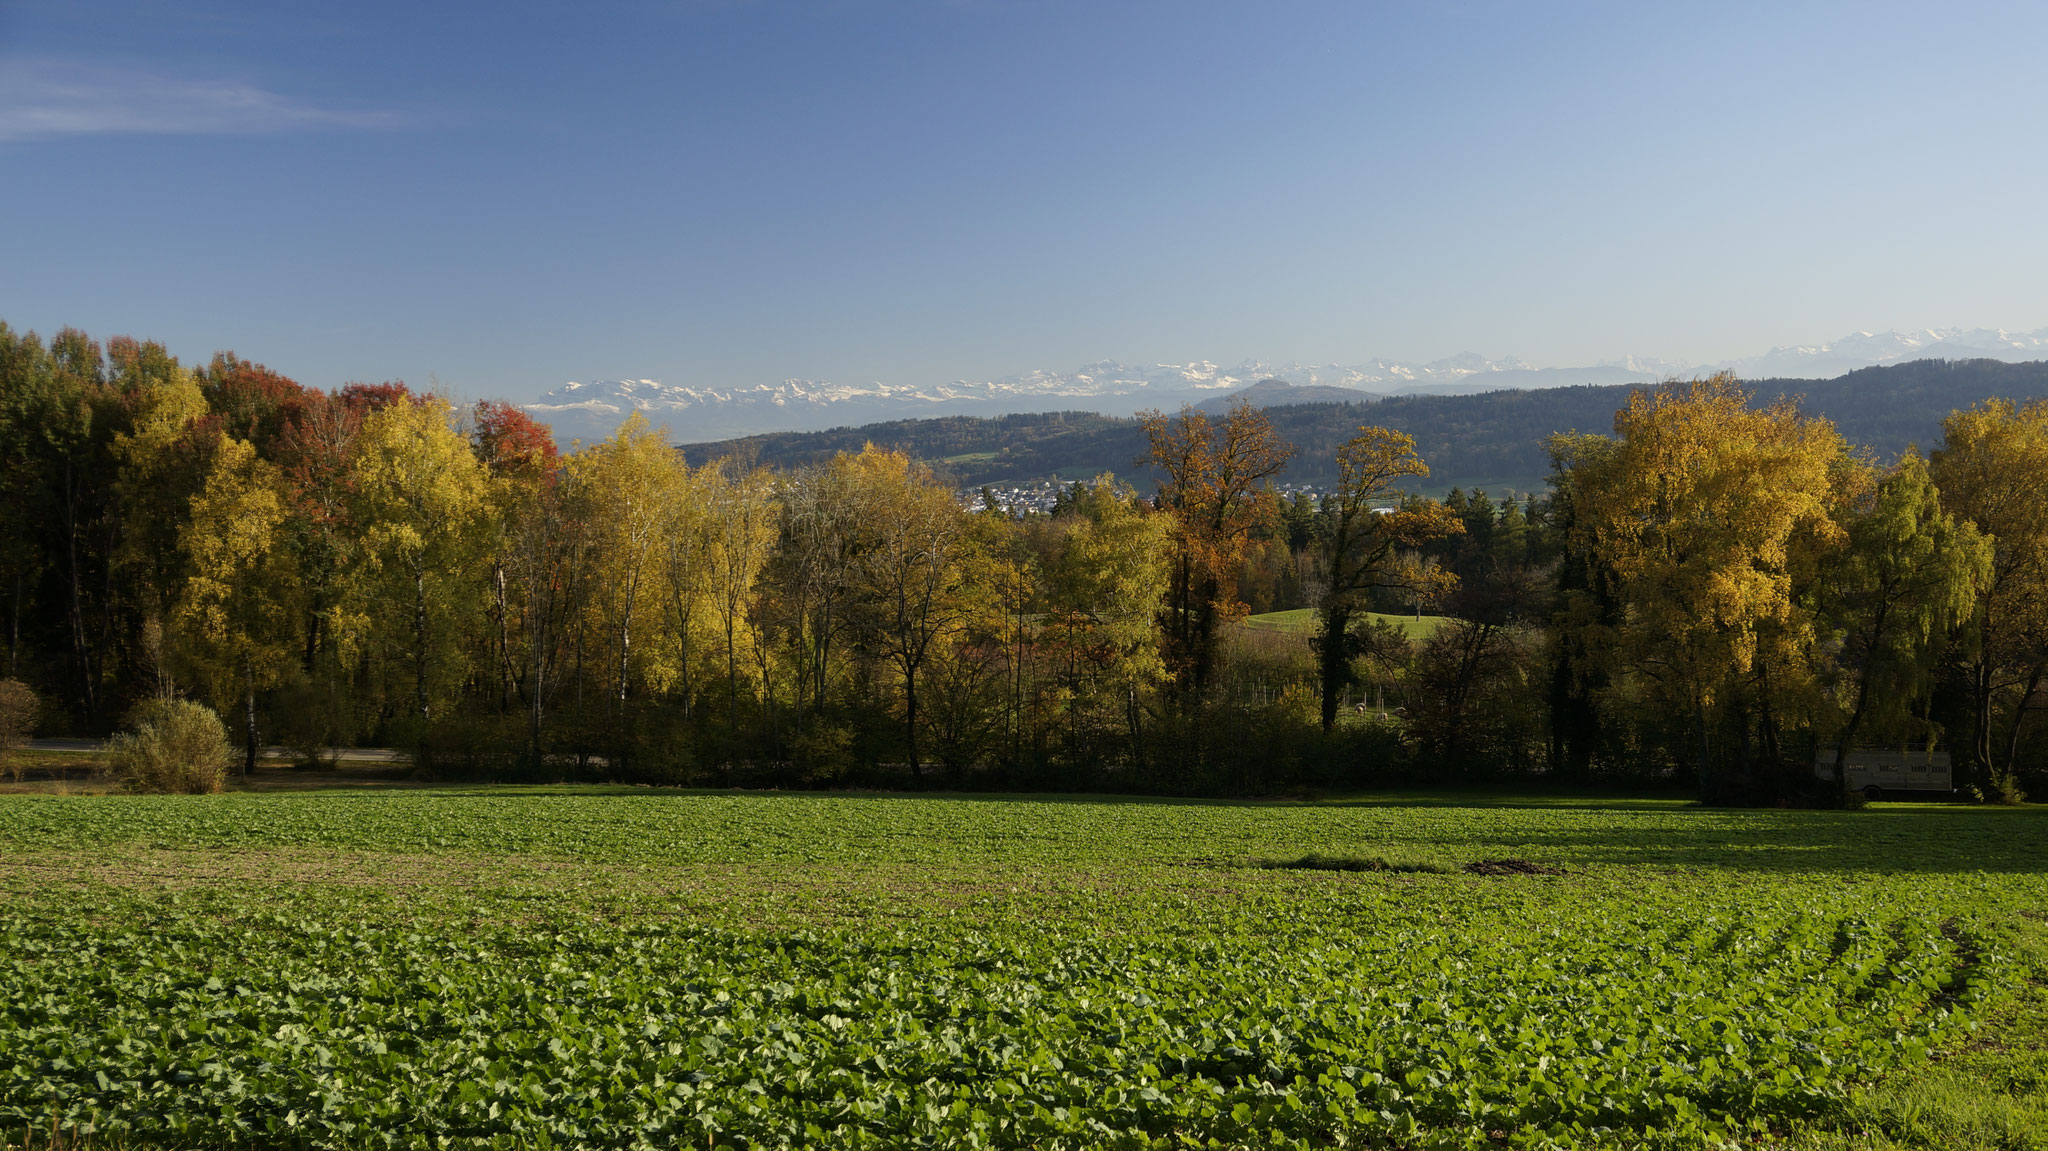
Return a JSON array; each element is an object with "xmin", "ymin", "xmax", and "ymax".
[{"xmin": 0, "ymin": 788, "xmax": 2048, "ymax": 1147}]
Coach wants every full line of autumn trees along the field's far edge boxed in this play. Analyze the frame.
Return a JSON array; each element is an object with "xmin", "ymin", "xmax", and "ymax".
[{"xmin": 0, "ymin": 317, "xmax": 2048, "ymax": 803}]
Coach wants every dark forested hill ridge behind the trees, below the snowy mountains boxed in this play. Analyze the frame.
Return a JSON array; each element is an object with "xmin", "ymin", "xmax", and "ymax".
[{"xmin": 684, "ymin": 360, "xmax": 2048, "ymax": 492}]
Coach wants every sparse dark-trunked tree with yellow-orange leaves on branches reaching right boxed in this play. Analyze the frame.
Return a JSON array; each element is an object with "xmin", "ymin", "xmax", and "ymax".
[{"xmin": 1313, "ymin": 428, "xmax": 1464, "ymax": 731}]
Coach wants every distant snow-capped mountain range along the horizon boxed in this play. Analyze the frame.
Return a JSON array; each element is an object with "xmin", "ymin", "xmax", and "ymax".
[{"xmin": 524, "ymin": 328, "xmax": 2048, "ymax": 444}]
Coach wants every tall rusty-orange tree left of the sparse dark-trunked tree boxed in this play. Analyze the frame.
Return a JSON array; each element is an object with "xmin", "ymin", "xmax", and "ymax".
[{"xmin": 1143, "ymin": 399, "xmax": 1294, "ymax": 696}]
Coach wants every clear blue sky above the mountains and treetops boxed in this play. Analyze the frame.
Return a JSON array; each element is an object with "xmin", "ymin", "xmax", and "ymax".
[{"xmin": 0, "ymin": 0, "xmax": 2048, "ymax": 397}]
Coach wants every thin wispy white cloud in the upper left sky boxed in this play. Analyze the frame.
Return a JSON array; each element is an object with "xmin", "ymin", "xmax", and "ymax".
[{"xmin": 0, "ymin": 57, "xmax": 397, "ymax": 141}]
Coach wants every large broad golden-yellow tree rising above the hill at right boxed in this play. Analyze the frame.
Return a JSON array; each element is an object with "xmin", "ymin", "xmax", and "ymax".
[{"xmin": 1571, "ymin": 375, "xmax": 1845, "ymax": 801}]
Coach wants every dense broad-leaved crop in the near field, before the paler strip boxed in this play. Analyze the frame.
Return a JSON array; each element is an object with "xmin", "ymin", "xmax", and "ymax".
[{"xmin": 0, "ymin": 897, "xmax": 1999, "ymax": 1147}]
